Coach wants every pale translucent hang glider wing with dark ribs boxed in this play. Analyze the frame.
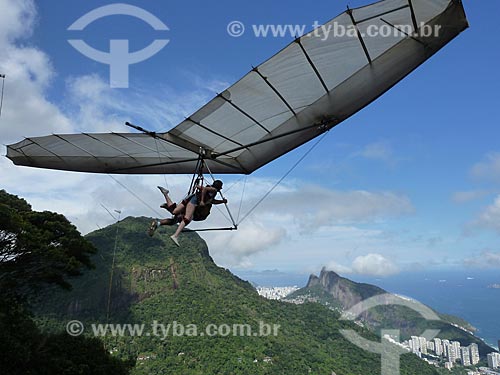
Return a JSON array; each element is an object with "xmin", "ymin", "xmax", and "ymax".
[{"xmin": 7, "ymin": 0, "xmax": 468, "ymax": 174}]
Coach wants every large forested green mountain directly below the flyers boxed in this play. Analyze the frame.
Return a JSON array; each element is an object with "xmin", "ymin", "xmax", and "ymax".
[{"xmin": 33, "ymin": 217, "xmax": 437, "ymax": 375}]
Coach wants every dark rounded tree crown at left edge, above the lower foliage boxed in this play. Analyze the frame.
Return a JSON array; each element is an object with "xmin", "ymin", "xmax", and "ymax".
[{"xmin": 0, "ymin": 190, "xmax": 95, "ymax": 295}]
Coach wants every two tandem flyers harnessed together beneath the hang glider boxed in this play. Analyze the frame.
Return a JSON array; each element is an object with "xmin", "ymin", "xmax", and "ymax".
[{"xmin": 148, "ymin": 180, "xmax": 227, "ymax": 246}]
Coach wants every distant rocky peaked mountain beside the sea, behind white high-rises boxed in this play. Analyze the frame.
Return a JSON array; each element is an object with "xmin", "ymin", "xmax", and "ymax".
[{"xmin": 285, "ymin": 269, "xmax": 494, "ymax": 358}]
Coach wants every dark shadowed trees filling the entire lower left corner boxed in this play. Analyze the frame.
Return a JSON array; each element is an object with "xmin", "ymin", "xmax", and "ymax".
[{"xmin": 0, "ymin": 190, "xmax": 135, "ymax": 375}]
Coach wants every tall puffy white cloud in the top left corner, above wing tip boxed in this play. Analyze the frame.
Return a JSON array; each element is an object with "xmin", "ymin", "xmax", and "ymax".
[{"xmin": 0, "ymin": 0, "xmax": 70, "ymax": 143}]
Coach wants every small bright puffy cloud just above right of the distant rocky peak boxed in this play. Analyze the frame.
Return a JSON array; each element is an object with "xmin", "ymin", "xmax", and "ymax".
[{"xmin": 326, "ymin": 253, "xmax": 400, "ymax": 276}]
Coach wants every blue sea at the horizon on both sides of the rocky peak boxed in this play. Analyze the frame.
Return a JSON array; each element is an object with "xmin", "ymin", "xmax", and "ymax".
[{"xmin": 237, "ymin": 271, "xmax": 500, "ymax": 348}]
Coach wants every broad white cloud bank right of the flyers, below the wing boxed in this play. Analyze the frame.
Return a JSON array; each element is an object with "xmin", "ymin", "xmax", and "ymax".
[{"xmin": 197, "ymin": 177, "xmax": 413, "ymax": 267}]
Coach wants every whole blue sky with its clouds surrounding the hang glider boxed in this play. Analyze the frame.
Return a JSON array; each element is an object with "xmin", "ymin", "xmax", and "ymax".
[{"xmin": 0, "ymin": 0, "xmax": 500, "ymax": 276}]
